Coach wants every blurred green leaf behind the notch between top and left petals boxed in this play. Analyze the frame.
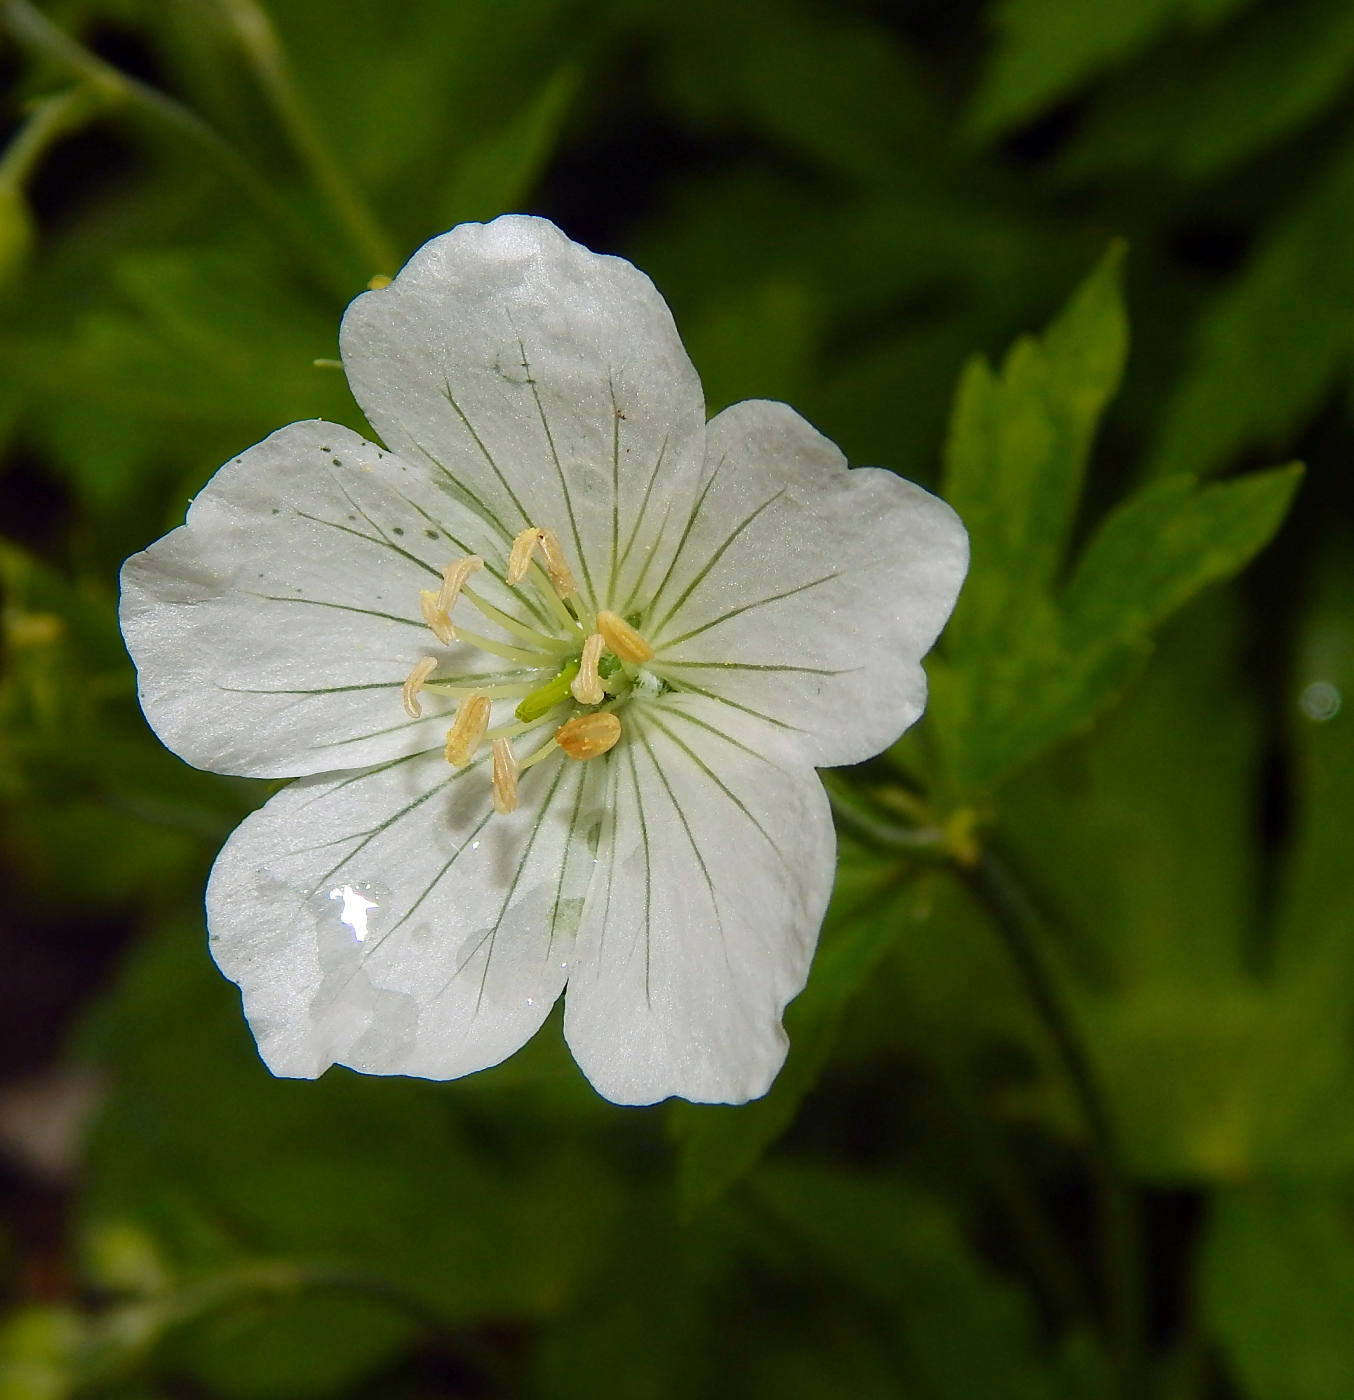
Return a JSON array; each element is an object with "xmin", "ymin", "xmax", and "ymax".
[{"xmin": 13, "ymin": 246, "xmax": 363, "ymax": 511}]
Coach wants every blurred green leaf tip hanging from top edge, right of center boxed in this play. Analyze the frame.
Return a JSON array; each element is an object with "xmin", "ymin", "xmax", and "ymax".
[{"xmin": 970, "ymin": 0, "xmax": 1255, "ymax": 134}]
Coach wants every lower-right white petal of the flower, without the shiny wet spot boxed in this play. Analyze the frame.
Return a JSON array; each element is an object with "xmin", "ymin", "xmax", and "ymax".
[{"xmin": 564, "ymin": 694, "xmax": 836, "ymax": 1103}]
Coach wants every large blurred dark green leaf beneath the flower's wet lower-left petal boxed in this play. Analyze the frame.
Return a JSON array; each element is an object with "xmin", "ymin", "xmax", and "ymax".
[{"xmin": 81, "ymin": 923, "xmax": 612, "ymax": 1332}]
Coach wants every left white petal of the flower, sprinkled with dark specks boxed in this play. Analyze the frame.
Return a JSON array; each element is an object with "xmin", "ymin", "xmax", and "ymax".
[{"xmin": 122, "ymin": 421, "xmax": 554, "ymax": 777}]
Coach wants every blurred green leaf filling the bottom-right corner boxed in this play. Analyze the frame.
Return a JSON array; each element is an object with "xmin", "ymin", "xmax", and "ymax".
[{"xmin": 1203, "ymin": 1187, "xmax": 1354, "ymax": 1400}]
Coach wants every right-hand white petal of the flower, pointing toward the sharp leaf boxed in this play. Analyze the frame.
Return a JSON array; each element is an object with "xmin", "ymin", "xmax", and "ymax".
[{"xmin": 641, "ymin": 400, "xmax": 968, "ymax": 767}]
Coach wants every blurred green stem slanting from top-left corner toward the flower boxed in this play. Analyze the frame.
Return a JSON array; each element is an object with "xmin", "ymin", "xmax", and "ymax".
[{"xmin": 0, "ymin": 0, "xmax": 353, "ymax": 297}]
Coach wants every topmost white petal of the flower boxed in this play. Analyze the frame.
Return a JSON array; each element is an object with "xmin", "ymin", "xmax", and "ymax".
[{"xmin": 342, "ymin": 214, "xmax": 704, "ymax": 608}]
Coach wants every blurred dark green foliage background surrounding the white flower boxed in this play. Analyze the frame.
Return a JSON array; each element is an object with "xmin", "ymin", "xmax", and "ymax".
[{"xmin": 0, "ymin": 0, "xmax": 1354, "ymax": 1400}]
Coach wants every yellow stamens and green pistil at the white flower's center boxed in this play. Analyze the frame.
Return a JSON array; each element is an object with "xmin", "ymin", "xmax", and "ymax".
[{"xmin": 402, "ymin": 526, "xmax": 654, "ymax": 813}]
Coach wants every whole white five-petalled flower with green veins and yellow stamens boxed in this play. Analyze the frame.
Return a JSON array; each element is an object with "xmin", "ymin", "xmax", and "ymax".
[{"xmin": 114, "ymin": 217, "xmax": 966, "ymax": 1103}]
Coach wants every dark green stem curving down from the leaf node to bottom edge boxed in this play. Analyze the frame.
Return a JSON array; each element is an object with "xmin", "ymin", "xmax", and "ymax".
[{"xmin": 955, "ymin": 851, "xmax": 1143, "ymax": 1400}]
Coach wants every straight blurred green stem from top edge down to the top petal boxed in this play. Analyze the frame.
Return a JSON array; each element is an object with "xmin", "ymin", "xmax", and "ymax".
[{"xmin": 220, "ymin": 0, "xmax": 400, "ymax": 274}]
